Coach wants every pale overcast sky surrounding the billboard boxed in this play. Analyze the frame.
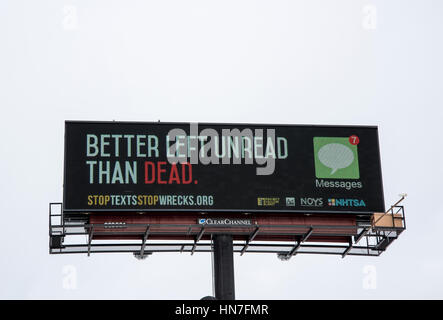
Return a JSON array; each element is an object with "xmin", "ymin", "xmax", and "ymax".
[{"xmin": 0, "ymin": 0, "xmax": 443, "ymax": 299}]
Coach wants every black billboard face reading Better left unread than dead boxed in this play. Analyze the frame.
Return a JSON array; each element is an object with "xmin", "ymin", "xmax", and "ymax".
[{"xmin": 63, "ymin": 121, "xmax": 385, "ymax": 214}]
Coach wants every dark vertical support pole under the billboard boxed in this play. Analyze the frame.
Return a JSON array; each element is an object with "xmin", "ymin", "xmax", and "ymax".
[{"xmin": 213, "ymin": 234, "xmax": 235, "ymax": 300}]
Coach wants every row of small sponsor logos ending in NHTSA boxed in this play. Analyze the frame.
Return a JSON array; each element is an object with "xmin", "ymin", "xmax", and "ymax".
[{"xmin": 257, "ymin": 197, "xmax": 366, "ymax": 208}]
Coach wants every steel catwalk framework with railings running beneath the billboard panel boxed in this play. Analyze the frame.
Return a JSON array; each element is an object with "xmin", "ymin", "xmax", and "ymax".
[{"xmin": 49, "ymin": 203, "xmax": 406, "ymax": 260}]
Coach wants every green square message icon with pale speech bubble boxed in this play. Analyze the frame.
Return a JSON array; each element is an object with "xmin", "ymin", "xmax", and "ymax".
[{"xmin": 314, "ymin": 137, "xmax": 360, "ymax": 179}]
